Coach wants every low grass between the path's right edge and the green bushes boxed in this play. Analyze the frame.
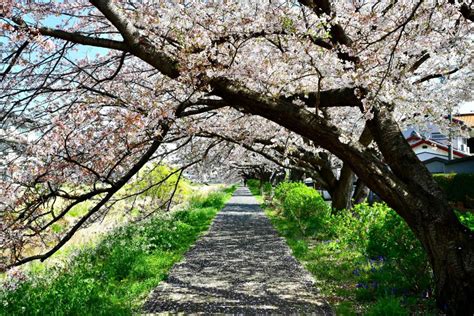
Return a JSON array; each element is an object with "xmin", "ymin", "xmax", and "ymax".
[{"xmin": 252, "ymin": 185, "xmax": 446, "ymax": 315}]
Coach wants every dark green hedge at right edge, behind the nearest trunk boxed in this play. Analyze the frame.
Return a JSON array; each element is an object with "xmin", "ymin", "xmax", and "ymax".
[{"xmin": 434, "ymin": 173, "xmax": 474, "ymax": 208}]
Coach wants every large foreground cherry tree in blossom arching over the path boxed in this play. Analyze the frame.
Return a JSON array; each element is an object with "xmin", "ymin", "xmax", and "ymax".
[{"xmin": 0, "ymin": 0, "xmax": 474, "ymax": 314}]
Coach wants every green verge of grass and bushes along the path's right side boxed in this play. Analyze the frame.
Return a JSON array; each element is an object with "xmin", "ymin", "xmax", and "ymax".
[{"xmin": 249, "ymin": 182, "xmax": 474, "ymax": 315}]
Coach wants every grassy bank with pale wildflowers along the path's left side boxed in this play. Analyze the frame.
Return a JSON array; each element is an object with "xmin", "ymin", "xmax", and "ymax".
[{"xmin": 0, "ymin": 187, "xmax": 235, "ymax": 315}]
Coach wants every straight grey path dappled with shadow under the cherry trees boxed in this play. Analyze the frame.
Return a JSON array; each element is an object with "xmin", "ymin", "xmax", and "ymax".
[{"xmin": 144, "ymin": 188, "xmax": 332, "ymax": 315}]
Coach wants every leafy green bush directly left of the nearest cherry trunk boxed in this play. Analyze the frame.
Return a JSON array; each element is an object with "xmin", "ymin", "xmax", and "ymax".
[{"xmin": 331, "ymin": 203, "xmax": 433, "ymax": 300}]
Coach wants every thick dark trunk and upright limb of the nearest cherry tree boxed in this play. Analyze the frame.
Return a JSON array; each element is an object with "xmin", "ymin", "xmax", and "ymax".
[{"xmin": 370, "ymin": 108, "xmax": 474, "ymax": 315}]
